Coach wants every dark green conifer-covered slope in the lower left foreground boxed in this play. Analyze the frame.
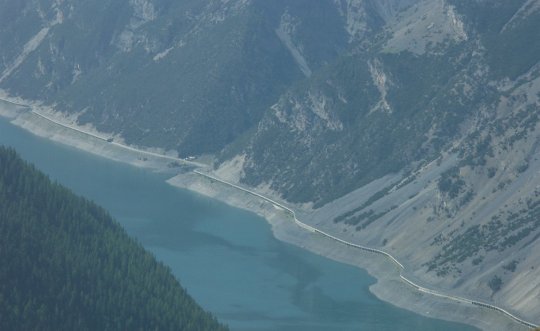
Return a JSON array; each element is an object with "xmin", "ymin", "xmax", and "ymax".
[{"xmin": 0, "ymin": 147, "xmax": 227, "ymax": 330}]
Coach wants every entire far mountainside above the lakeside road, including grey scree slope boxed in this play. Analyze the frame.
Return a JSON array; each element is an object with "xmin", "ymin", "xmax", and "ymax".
[{"xmin": 0, "ymin": 0, "xmax": 540, "ymax": 326}]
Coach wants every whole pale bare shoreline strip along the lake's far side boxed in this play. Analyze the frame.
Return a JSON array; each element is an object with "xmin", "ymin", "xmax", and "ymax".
[{"xmin": 0, "ymin": 99, "xmax": 533, "ymax": 330}]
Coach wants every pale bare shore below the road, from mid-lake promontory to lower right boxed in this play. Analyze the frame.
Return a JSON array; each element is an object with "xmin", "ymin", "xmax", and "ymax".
[{"xmin": 168, "ymin": 173, "xmax": 528, "ymax": 331}]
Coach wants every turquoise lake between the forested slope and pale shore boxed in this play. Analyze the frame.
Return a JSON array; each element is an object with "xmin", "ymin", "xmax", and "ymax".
[{"xmin": 0, "ymin": 119, "xmax": 476, "ymax": 331}]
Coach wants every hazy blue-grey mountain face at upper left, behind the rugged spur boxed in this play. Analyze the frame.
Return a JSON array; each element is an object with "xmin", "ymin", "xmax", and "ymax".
[{"xmin": 0, "ymin": 0, "xmax": 414, "ymax": 155}]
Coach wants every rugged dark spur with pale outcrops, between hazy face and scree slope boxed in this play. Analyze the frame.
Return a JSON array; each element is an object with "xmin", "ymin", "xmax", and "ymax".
[{"xmin": 238, "ymin": 1, "xmax": 494, "ymax": 206}]
